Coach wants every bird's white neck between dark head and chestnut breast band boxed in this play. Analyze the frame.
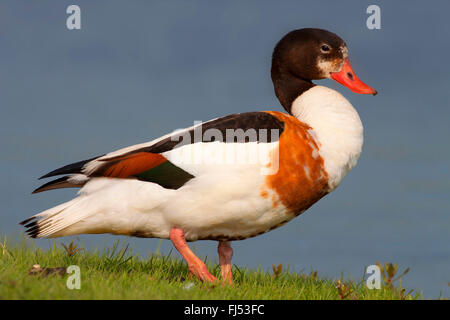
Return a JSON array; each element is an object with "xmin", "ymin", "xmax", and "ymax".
[{"xmin": 291, "ymin": 86, "xmax": 363, "ymax": 191}]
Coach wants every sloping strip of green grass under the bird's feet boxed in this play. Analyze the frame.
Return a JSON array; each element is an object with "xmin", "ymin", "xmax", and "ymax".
[{"xmin": 0, "ymin": 238, "xmax": 422, "ymax": 300}]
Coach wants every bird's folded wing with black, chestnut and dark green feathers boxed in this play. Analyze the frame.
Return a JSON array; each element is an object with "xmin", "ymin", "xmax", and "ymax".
[{"xmin": 33, "ymin": 112, "xmax": 284, "ymax": 193}]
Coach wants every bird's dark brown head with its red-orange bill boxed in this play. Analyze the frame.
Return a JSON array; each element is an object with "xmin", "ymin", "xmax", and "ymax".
[{"xmin": 271, "ymin": 28, "xmax": 377, "ymax": 109}]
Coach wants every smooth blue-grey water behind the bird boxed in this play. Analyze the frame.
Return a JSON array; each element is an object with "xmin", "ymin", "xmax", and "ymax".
[{"xmin": 0, "ymin": 0, "xmax": 450, "ymax": 298}]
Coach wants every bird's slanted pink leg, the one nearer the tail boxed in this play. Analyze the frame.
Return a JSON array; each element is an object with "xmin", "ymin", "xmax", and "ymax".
[{"xmin": 170, "ymin": 228, "xmax": 216, "ymax": 282}]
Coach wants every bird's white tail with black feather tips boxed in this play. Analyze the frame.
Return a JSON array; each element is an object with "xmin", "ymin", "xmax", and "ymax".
[{"xmin": 20, "ymin": 195, "xmax": 92, "ymax": 238}]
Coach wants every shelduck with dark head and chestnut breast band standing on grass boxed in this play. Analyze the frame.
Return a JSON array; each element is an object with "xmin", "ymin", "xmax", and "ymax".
[{"xmin": 20, "ymin": 28, "xmax": 377, "ymax": 285}]
